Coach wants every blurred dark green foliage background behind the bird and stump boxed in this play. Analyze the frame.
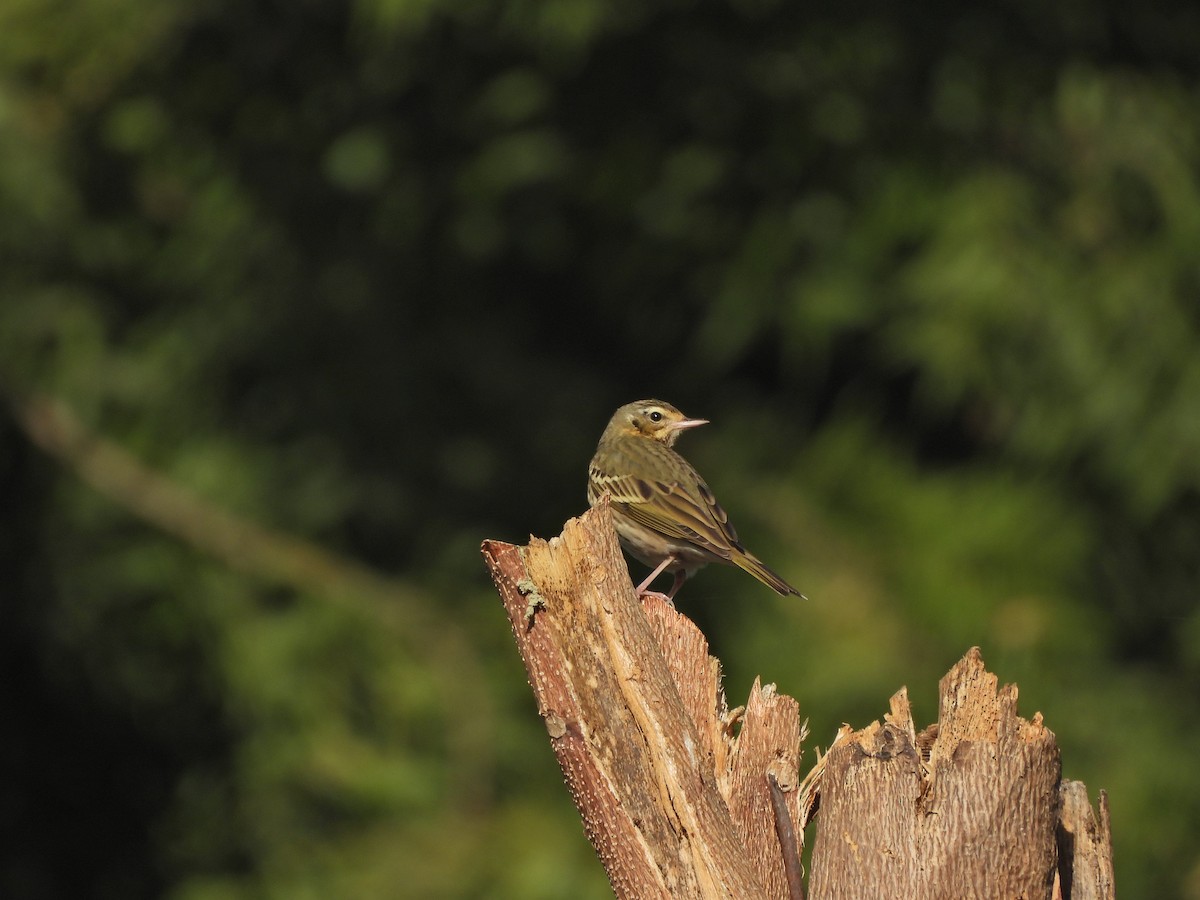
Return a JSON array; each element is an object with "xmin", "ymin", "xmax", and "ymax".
[{"xmin": 0, "ymin": 0, "xmax": 1200, "ymax": 900}]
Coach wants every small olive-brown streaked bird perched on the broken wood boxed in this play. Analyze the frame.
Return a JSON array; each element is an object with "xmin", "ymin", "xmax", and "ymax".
[{"xmin": 588, "ymin": 400, "xmax": 804, "ymax": 602}]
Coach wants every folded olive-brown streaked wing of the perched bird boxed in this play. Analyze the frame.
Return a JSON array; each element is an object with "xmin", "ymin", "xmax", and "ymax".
[{"xmin": 592, "ymin": 469, "xmax": 744, "ymax": 559}]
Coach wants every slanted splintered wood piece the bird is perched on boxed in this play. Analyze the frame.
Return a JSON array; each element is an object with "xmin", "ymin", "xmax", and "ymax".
[{"xmin": 482, "ymin": 506, "xmax": 803, "ymax": 900}]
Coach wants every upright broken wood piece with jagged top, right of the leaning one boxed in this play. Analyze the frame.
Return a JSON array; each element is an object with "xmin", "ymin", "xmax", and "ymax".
[{"xmin": 810, "ymin": 649, "xmax": 1060, "ymax": 900}]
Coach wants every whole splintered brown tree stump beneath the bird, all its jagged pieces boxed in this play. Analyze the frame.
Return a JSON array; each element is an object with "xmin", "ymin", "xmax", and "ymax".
[{"xmin": 482, "ymin": 504, "xmax": 1114, "ymax": 900}]
